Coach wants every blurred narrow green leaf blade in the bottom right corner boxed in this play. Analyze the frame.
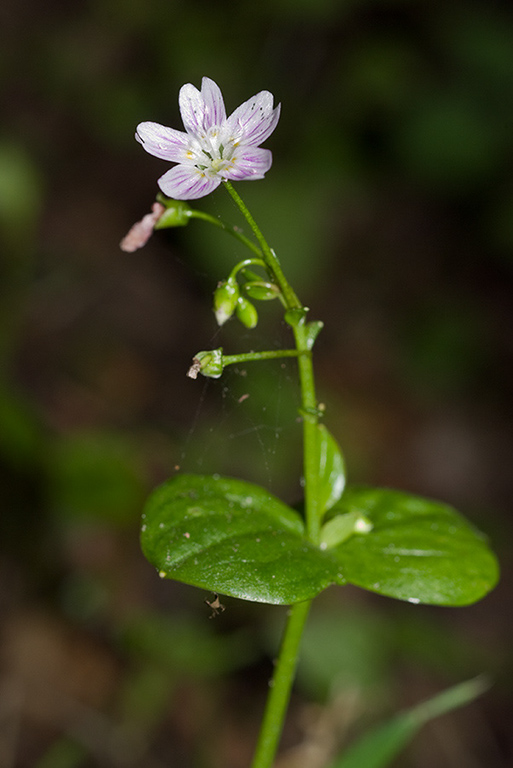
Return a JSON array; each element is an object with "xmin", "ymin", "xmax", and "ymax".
[{"xmin": 331, "ymin": 677, "xmax": 488, "ymax": 768}]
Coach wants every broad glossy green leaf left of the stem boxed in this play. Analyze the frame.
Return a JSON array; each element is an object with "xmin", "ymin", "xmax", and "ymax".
[{"xmin": 141, "ymin": 475, "xmax": 344, "ymax": 605}]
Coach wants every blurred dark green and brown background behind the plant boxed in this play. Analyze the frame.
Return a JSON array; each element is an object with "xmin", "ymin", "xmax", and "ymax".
[{"xmin": 0, "ymin": 0, "xmax": 513, "ymax": 768}]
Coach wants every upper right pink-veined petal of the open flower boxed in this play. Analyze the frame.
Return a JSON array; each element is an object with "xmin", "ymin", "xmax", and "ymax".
[{"xmin": 223, "ymin": 91, "xmax": 281, "ymax": 146}]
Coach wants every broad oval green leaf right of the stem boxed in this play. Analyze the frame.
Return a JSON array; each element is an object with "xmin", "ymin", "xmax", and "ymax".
[{"xmin": 330, "ymin": 488, "xmax": 498, "ymax": 606}]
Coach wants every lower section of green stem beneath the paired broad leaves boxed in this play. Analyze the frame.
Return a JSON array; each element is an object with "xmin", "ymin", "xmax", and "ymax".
[{"xmin": 252, "ymin": 600, "xmax": 312, "ymax": 768}]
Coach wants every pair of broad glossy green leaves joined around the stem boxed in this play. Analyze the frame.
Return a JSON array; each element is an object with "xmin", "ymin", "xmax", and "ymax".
[{"xmin": 141, "ymin": 474, "xmax": 498, "ymax": 606}]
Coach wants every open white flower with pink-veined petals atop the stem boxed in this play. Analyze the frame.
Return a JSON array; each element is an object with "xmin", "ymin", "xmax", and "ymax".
[{"xmin": 135, "ymin": 77, "xmax": 281, "ymax": 200}]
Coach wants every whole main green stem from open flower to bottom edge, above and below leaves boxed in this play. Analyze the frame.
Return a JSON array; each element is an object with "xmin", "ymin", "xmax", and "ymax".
[{"xmin": 224, "ymin": 181, "xmax": 320, "ymax": 768}]
